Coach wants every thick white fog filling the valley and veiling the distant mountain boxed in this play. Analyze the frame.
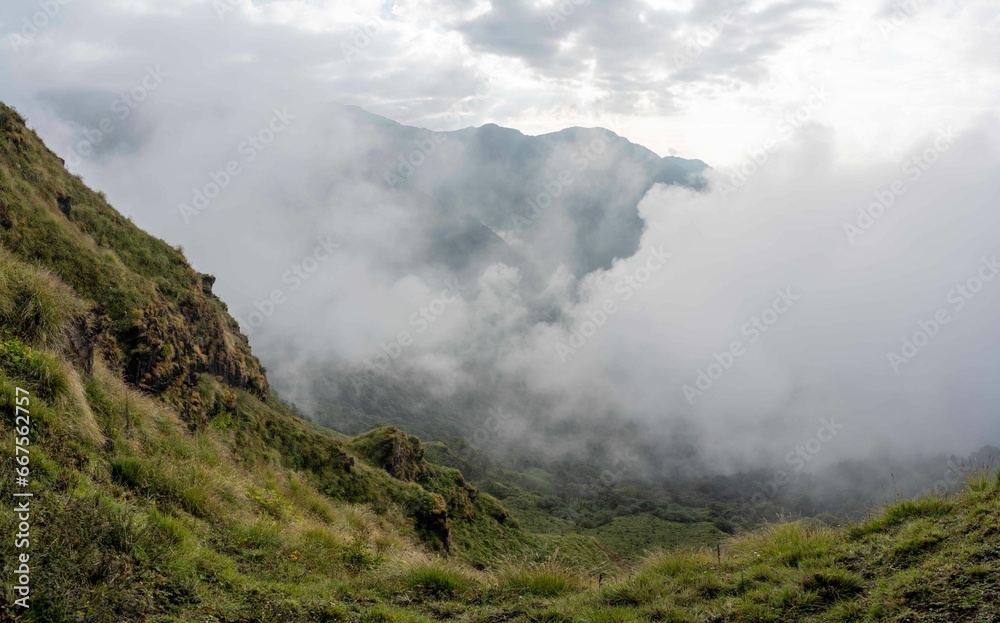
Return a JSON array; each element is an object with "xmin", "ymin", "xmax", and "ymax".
[{"xmin": 0, "ymin": 3, "xmax": 1000, "ymax": 482}]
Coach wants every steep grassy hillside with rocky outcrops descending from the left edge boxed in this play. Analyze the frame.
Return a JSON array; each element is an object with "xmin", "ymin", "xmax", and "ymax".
[{"xmin": 0, "ymin": 101, "xmax": 606, "ymax": 621}]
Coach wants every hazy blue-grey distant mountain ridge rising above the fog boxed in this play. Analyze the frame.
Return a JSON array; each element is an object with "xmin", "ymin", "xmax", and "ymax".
[{"xmin": 326, "ymin": 106, "xmax": 707, "ymax": 277}]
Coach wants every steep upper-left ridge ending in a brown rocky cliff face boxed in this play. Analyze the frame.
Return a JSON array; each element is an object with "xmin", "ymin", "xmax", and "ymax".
[{"xmin": 0, "ymin": 104, "xmax": 269, "ymax": 423}]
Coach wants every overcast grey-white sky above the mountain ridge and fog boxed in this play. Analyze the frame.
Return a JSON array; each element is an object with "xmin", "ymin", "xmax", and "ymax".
[{"xmin": 0, "ymin": 0, "xmax": 1000, "ymax": 166}]
